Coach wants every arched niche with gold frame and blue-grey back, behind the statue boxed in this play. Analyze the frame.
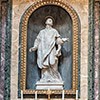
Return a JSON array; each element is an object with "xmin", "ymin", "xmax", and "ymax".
[{"xmin": 20, "ymin": 0, "xmax": 79, "ymax": 97}]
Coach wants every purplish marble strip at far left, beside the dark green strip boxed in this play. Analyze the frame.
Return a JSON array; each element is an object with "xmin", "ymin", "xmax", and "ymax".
[{"xmin": 0, "ymin": 2, "xmax": 7, "ymax": 100}]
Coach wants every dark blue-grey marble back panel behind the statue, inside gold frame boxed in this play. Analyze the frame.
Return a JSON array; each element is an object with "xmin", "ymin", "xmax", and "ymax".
[{"xmin": 26, "ymin": 5, "xmax": 73, "ymax": 90}]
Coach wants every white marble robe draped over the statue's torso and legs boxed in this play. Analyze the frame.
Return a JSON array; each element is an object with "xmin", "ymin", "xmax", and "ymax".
[{"xmin": 34, "ymin": 28, "xmax": 60, "ymax": 69}]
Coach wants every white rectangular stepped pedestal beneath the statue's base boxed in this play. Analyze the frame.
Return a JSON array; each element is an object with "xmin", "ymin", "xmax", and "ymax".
[{"xmin": 36, "ymin": 82, "xmax": 64, "ymax": 90}]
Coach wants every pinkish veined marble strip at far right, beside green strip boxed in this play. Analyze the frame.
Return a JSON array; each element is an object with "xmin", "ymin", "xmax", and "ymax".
[{"xmin": 94, "ymin": 0, "xmax": 100, "ymax": 100}]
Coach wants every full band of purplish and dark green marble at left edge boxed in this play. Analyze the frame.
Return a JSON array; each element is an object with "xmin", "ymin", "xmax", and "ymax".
[{"xmin": 0, "ymin": 0, "xmax": 12, "ymax": 100}]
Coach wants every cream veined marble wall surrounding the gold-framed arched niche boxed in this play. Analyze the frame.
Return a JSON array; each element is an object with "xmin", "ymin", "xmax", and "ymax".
[{"xmin": 11, "ymin": 0, "xmax": 88, "ymax": 100}]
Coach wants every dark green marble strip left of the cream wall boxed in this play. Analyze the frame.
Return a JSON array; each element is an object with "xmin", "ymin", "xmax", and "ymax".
[{"xmin": 4, "ymin": 0, "xmax": 12, "ymax": 100}]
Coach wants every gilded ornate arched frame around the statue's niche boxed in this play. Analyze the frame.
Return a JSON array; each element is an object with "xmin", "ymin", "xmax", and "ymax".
[{"xmin": 20, "ymin": 0, "xmax": 79, "ymax": 95}]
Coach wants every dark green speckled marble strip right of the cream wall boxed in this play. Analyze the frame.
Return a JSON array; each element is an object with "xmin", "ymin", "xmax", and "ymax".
[{"xmin": 88, "ymin": 0, "xmax": 94, "ymax": 100}]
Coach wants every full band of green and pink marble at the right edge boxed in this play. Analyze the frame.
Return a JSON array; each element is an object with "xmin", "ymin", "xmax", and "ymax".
[{"xmin": 88, "ymin": 0, "xmax": 100, "ymax": 100}]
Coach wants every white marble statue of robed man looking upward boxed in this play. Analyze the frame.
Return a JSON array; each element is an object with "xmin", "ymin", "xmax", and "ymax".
[{"xmin": 29, "ymin": 18, "xmax": 68, "ymax": 82}]
